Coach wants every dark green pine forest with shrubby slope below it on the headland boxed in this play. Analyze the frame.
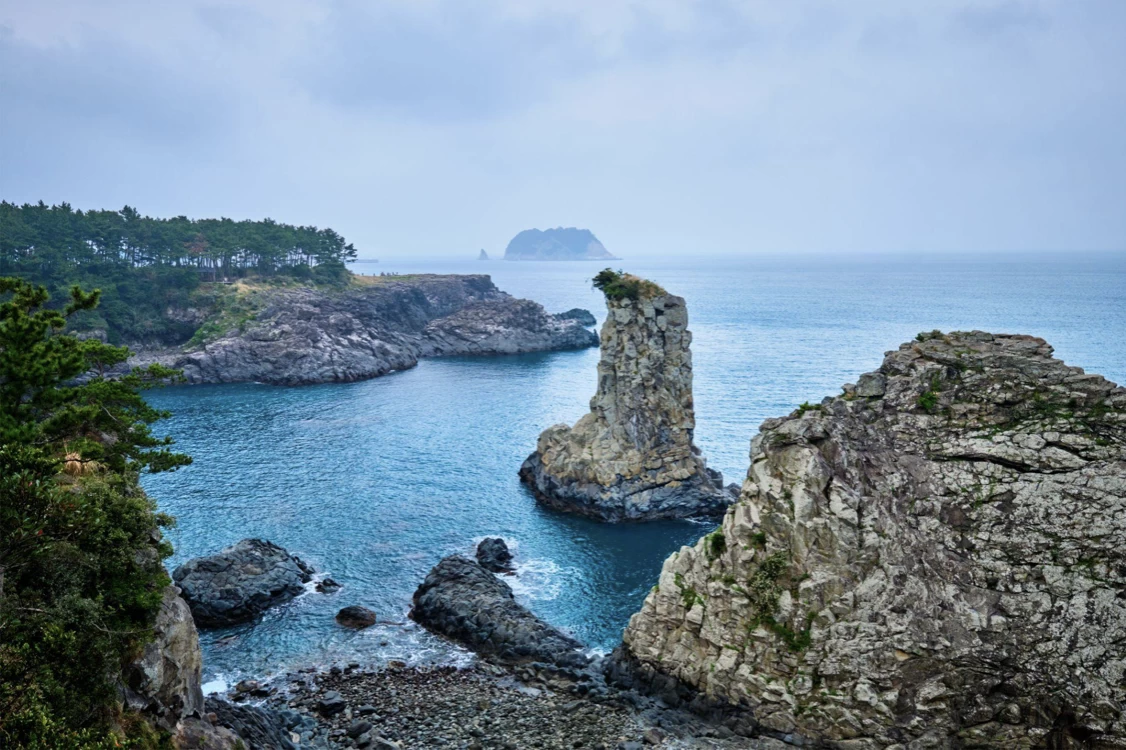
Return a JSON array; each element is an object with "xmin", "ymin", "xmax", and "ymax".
[{"xmin": 0, "ymin": 202, "xmax": 356, "ymax": 343}]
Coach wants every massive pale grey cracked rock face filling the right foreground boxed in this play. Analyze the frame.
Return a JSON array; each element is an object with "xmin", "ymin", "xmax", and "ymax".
[{"xmin": 614, "ymin": 332, "xmax": 1126, "ymax": 749}]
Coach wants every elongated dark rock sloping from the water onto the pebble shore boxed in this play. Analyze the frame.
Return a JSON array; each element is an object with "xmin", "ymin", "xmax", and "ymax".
[{"xmin": 410, "ymin": 555, "xmax": 588, "ymax": 668}]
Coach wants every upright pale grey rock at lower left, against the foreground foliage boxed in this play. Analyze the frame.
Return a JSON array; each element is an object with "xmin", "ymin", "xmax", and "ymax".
[{"xmin": 123, "ymin": 586, "xmax": 204, "ymax": 732}]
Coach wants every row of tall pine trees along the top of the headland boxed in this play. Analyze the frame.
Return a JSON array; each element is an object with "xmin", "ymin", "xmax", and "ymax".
[{"xmin": 0, "ymin": 200, "xmax": 356, "ymax": 280}]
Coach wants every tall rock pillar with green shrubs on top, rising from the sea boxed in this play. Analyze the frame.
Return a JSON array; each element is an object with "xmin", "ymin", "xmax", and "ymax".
[{"xmin": 520, "ymin": 269, "xmax": 734, "ymax": 521}]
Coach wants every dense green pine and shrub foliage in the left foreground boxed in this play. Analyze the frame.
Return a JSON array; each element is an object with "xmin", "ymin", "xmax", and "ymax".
[{"xmin": 0, "ymin": 278, "xmax": 189, "ymax": 749}]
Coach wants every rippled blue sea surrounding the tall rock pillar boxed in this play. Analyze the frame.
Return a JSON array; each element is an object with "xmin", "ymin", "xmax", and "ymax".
[{"xmin": 144, "ymin": 258, "xmax": 1126, "ymax": 687}]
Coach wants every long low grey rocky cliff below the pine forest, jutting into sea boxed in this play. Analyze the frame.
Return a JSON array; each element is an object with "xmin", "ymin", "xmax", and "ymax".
[{"xmin": 131, "ymin": 275, "xmax": 598, "ymax": 385}]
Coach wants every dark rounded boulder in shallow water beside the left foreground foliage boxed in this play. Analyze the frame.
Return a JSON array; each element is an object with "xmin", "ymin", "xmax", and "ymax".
[{"xmin": 172, "ymin": 539, "xmax": 312, "ymax": 627}]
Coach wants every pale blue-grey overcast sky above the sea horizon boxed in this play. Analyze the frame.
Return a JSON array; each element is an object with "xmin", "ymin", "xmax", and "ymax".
[{"xmin": 0, "ymin": 0, "xmax": 1126, "ymax": 258}]
